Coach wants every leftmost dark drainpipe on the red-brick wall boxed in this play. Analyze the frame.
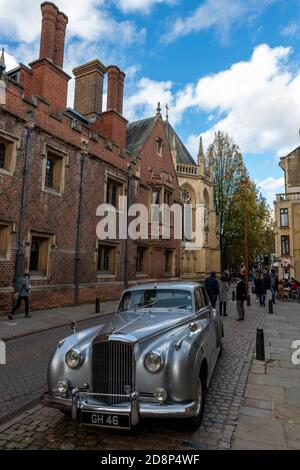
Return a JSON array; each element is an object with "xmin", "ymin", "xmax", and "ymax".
[{"xmin": 15, "ymin": 111, "xmax": 35, "ymax": 289}]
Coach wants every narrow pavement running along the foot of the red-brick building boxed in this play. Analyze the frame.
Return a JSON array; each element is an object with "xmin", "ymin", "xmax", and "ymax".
[{"xmin": 0, "ymin": 301, "xmax": 119, "ymax": 341}]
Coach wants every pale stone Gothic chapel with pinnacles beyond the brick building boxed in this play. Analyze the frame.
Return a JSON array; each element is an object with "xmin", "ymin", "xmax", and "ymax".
[{"xmin": 165, "ymin": 122, "xmax": 221, "ymax": 280}]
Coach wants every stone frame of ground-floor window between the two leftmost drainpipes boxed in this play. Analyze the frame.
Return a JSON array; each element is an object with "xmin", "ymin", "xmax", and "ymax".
[{"xmin": 26, "ymin": 229, "xmax": 56, "ymax": 280}]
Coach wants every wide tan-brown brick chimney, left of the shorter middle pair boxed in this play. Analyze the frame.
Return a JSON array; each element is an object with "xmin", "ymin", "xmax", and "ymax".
[{"xmin": 73, "ymin": 60, "xmax": 106, "ymax": 118}]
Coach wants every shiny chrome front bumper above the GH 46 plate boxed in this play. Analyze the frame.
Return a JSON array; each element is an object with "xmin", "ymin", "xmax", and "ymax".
[{"xmin": 41, "ymin": 393, "xmax": 196, "ymax": 426}]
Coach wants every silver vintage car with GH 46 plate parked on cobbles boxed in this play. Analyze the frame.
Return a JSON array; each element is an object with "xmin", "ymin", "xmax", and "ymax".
[{"xmin": 42, "ymin": 282, "xmax": 223, "ymax": 429}]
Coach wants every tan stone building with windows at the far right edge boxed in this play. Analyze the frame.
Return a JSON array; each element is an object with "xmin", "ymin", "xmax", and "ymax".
[{"xmin": 275, "ymin": 147, "xmax": 300, "ymax": 279}]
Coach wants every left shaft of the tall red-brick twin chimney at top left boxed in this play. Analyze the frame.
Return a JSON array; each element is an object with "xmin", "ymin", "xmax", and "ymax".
[{"xmin": 40, "ymin": 2, "xmax": 59, "ymax": 61}]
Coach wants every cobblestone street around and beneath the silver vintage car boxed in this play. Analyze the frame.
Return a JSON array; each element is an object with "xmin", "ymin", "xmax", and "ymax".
[{"xmin": 0, "ymin": 298, "xmax": 266, "ymax": 450}]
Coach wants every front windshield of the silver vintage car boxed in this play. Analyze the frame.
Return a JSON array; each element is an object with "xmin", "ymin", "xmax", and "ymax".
[{"xmin": 119, "ymin": 289, "xmax": 193, "ymax": 312}]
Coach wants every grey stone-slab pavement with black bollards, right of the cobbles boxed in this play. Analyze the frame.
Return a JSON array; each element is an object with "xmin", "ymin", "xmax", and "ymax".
[{"xmin": 233, "ymin": 302, "xmax": 300, "ymax": 450}]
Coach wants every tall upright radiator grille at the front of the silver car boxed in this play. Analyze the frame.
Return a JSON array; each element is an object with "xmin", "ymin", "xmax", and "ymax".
[{"xmin": 92, "ymin": 341, "xmax": 135, "ymax": 405}]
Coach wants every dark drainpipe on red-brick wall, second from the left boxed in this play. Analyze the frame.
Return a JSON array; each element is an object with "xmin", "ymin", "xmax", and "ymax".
[{"xmin": 74, "ymin": 139, "xmax": 88, "ymax": 305}]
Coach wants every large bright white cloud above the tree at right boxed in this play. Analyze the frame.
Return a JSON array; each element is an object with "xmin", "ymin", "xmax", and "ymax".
[{"xmin": 180, "ymin": 44, "xmax": 300, "ymax": 155}]
